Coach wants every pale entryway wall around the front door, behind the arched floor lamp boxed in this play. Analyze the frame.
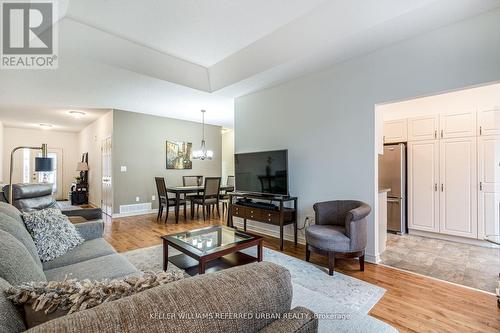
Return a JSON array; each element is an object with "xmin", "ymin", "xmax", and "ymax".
[{"xmin": 2, "ymin": 127, "xmax": 78, "ymax": 198}]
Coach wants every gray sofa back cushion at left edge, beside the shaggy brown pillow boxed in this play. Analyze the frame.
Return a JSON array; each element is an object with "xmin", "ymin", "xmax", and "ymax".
[{"xmin": 0, "ymin": 230, "xmax": 47, "ymax": 285}]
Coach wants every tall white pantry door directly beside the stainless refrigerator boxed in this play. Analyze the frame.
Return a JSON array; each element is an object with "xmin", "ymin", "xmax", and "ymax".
[{"xmin": 408, "ymin": 140, "xmax": 439, "ymax": 232}]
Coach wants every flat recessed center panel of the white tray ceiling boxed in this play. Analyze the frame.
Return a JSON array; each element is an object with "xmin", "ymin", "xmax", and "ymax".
[{"xmin": 66, "ymin": 0, "xmax": 325, "ymax": 67}]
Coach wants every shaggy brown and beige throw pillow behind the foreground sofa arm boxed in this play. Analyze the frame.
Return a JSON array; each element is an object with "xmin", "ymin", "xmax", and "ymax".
[{"xmin": 5, "ymin": 270, "xmax": 184, "ymax": 328}]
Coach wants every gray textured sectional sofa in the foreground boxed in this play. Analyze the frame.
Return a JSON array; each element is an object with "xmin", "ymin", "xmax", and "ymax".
[{"xmin": 0, "ymin": 202, "xmax": 318, "ymax": 333}]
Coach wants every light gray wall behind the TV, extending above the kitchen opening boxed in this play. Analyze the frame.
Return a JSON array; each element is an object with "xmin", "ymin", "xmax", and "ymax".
[{"xmin": 235, "ymin": 11, "xmax": 500, "ymax": 261}]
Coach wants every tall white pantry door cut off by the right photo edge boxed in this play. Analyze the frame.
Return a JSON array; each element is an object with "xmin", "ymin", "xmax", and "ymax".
[{"xmin": 477, "ymin": 135, "xmax": 500, "ymax": 239}]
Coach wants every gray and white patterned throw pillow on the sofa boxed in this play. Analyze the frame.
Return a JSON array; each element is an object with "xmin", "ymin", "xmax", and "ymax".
[{"xmin": 23, "ymin": 208, "xmax": 85, "ymax": 262}]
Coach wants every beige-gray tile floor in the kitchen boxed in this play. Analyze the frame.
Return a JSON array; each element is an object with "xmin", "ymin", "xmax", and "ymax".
[{"xmin": 382, "ymin": 234, "xmax": 500, "ymax": 292}]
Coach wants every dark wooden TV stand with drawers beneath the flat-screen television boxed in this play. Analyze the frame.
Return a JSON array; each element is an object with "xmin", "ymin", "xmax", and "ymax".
[{"xmin": 227, "ymin": 192, "xmax": 297, "ymax": 251}]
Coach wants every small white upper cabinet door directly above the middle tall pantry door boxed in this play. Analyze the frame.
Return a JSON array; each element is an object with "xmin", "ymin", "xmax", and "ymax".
[{"xmin": 439, "ymin": 111, "xmax": 476, "ymax": 139}]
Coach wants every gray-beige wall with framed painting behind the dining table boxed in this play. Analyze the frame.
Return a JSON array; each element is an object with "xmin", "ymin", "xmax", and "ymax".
[{"xmin": 112, "ymin": 110, "xmax": 224, "ymax": 213}]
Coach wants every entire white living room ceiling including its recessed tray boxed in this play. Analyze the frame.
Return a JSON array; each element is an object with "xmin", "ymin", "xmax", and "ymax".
[{"xmin": 0, "ymin": 0, "xmax": 500, "ymax": 127}]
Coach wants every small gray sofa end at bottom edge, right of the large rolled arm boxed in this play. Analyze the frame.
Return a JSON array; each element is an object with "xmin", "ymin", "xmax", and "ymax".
[{"xmin": 259, "ymin": 306, "xmax": 318, "ymax": 333}]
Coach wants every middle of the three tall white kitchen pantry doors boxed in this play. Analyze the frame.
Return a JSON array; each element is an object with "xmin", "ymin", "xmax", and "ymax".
[{"xmin": 439, "ymin": 137, "xmax": 478, "ymax": 238}]
